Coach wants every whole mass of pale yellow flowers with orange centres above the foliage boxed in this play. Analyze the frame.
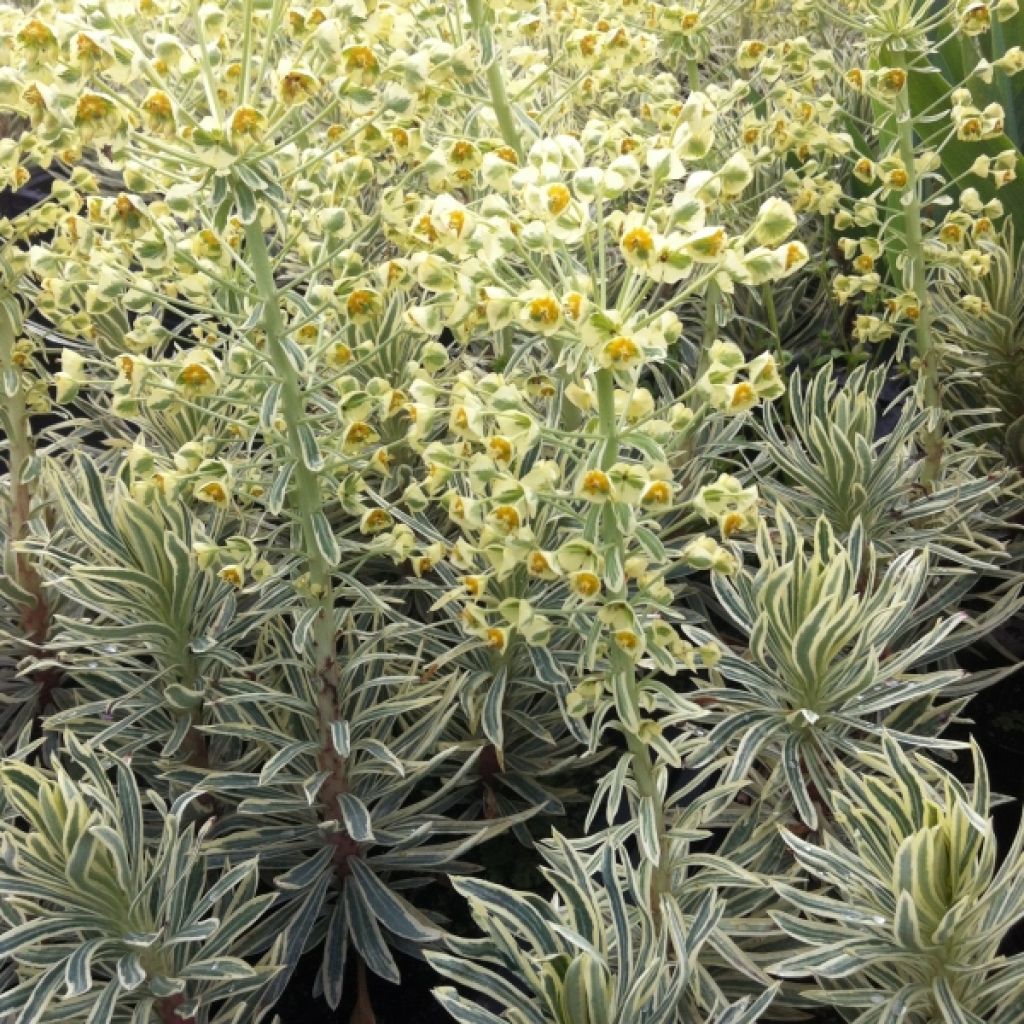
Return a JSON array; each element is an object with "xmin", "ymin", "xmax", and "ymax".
[{"xmin": 9, "ymin": 0, "xmax": 1016, "ymax": 745}]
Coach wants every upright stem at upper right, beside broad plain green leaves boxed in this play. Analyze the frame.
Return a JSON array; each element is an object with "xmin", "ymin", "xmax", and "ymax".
[{"xmin": 893, "ymin": 58, "xmax": 943, "ymax": 485}]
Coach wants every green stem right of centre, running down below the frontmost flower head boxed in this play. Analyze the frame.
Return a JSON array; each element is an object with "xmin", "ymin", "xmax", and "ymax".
[{"xmin": 596, "ymin": 370, "xmax": 672, "ymax": 923}]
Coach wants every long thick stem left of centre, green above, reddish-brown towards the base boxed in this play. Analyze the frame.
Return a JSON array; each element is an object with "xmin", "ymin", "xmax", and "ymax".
[{"xmin": 237, "ymin": 205, "xmax": 348, "ymax": 819}]
